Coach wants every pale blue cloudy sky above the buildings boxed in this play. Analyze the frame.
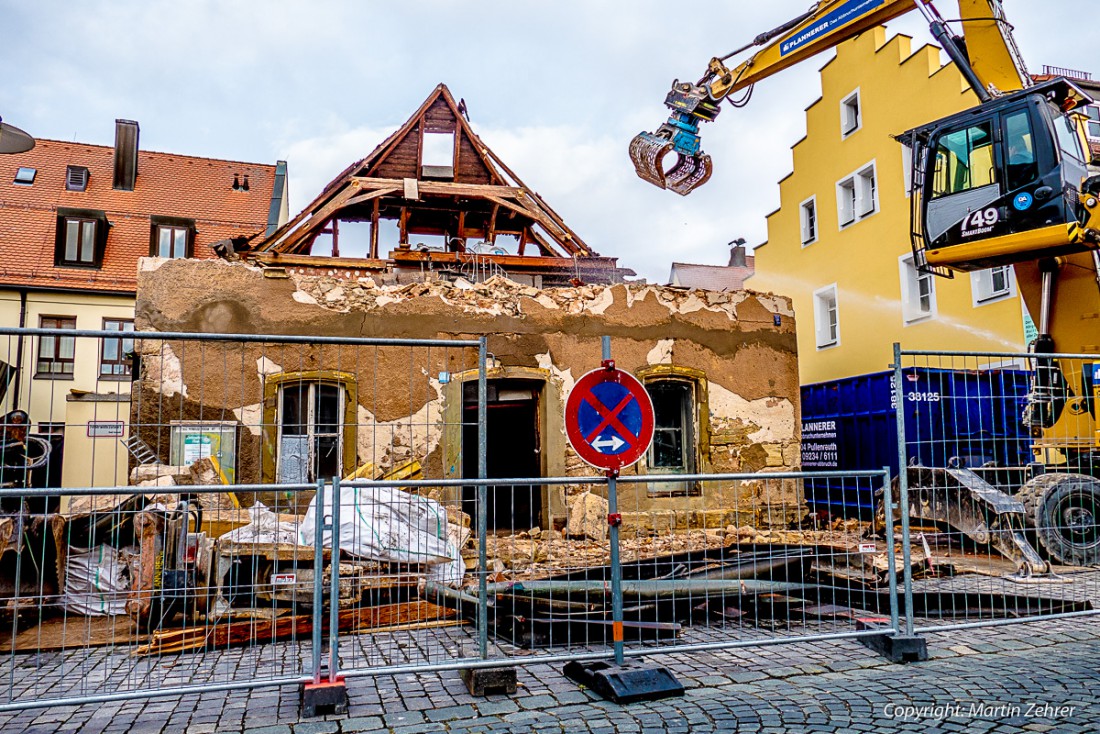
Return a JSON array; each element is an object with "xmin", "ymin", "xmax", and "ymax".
[{"xmin": 0, "ymin": 0, "xmax": 1100, "ymax": 282}]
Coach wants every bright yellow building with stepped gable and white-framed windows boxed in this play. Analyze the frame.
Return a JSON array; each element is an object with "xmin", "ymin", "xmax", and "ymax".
[{"xmin": 748, "ymin": 28, "xmax": 1030, "ymax": 385}]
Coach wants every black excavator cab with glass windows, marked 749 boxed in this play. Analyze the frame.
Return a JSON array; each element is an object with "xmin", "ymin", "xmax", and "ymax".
[{"xmin": 902, "ymin": 79, "xmax": 1100, "ymax": 275}]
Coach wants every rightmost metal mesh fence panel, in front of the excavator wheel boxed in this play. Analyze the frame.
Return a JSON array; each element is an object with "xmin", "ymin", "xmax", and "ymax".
[{"xmin": 893, "ymin": 344, "xmax": 1100, "ymax": 633}]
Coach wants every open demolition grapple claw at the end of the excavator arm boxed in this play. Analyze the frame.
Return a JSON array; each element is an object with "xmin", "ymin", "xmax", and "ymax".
[{"xmin": 630, "ymin": 81, "xmax": 719, "ymax": 196}]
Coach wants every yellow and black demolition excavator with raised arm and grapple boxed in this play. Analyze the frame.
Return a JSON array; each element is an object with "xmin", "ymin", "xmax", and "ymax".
[{"xmin": 629, "ymin": 0, "xmax": 1100, "ymax": 576}]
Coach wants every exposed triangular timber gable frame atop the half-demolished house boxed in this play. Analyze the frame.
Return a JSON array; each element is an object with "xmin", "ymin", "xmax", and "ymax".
[{"xmin": 243, "ymin": 84, "xmax": 634, "ymax": 285}]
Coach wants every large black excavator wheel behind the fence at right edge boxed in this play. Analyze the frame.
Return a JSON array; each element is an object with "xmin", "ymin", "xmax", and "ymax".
[{"xmin": 1016, "ymin": 473, "xmax": 1100, "ymax": 566}]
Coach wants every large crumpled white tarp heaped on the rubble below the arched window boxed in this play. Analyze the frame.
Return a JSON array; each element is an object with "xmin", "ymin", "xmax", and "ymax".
[{"xmin": 298, "ymin": 484, "xmax": 465, "ymax": 583}]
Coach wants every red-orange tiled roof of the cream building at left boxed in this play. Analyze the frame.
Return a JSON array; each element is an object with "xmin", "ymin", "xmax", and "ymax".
[{"xmin": 0, "ymin": 140, "xmax": 275, "ymax": 292}]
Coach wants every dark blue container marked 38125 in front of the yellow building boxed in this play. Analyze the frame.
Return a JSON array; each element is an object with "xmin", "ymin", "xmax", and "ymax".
[{"xmin": 802, "ymin": 368, "xmax": 1031, "ymax": 516}]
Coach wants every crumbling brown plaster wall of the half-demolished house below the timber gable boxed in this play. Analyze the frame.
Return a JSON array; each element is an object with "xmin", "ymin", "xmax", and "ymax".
[{"xmin": 135, "ymin": 261, "xmax": 803, "ymax": 532}]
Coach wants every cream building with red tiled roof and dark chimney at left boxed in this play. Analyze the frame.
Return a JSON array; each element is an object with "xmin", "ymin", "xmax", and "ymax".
[{"xmin": 0, "ymin": 120, "xmax": 287, "ymax": 486}]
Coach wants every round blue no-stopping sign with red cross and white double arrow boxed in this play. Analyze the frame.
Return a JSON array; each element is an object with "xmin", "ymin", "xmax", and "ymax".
[{"xmin": 565, "ymin": 361, "xmax": 653, "ymax": 471}]
